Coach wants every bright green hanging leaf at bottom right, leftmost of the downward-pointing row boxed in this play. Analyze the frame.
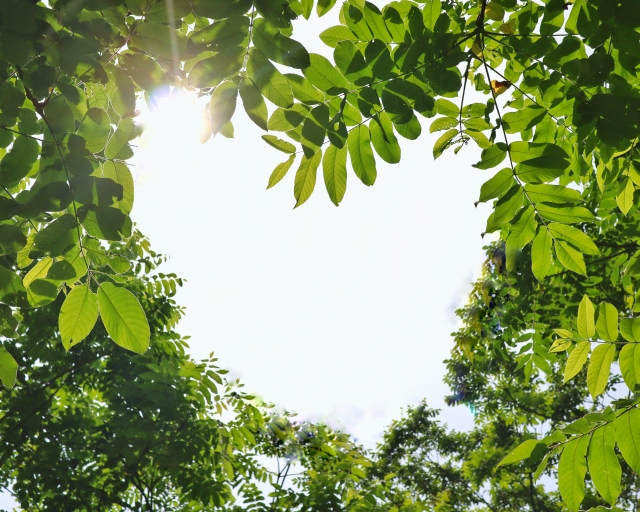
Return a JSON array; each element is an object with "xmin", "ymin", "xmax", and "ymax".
[{"xmin": 558, "ymin": 436, "xmax": 589, "ymax": 512}]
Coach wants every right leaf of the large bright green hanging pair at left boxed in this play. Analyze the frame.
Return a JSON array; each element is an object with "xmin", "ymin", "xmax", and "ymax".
[{"xmin": 98, "ymin": 282, "xmax": 151, "ymax": 354}]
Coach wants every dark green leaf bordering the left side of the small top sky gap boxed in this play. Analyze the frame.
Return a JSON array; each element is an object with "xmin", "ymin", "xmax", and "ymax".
[{"xmin": 252, "ymin": 18, "xmax": 310, "ymax": 69}]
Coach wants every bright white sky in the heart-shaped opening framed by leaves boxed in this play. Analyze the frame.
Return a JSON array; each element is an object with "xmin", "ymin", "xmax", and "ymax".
[{"xmin": 133, "ymin": 9, "xmax": 492, "ymax": 446}]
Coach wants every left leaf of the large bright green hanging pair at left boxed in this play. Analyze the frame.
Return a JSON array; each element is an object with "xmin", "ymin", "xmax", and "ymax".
[{"xmin": 58, "ymin": 284, "xmax": 98, "ymax": 351}]
